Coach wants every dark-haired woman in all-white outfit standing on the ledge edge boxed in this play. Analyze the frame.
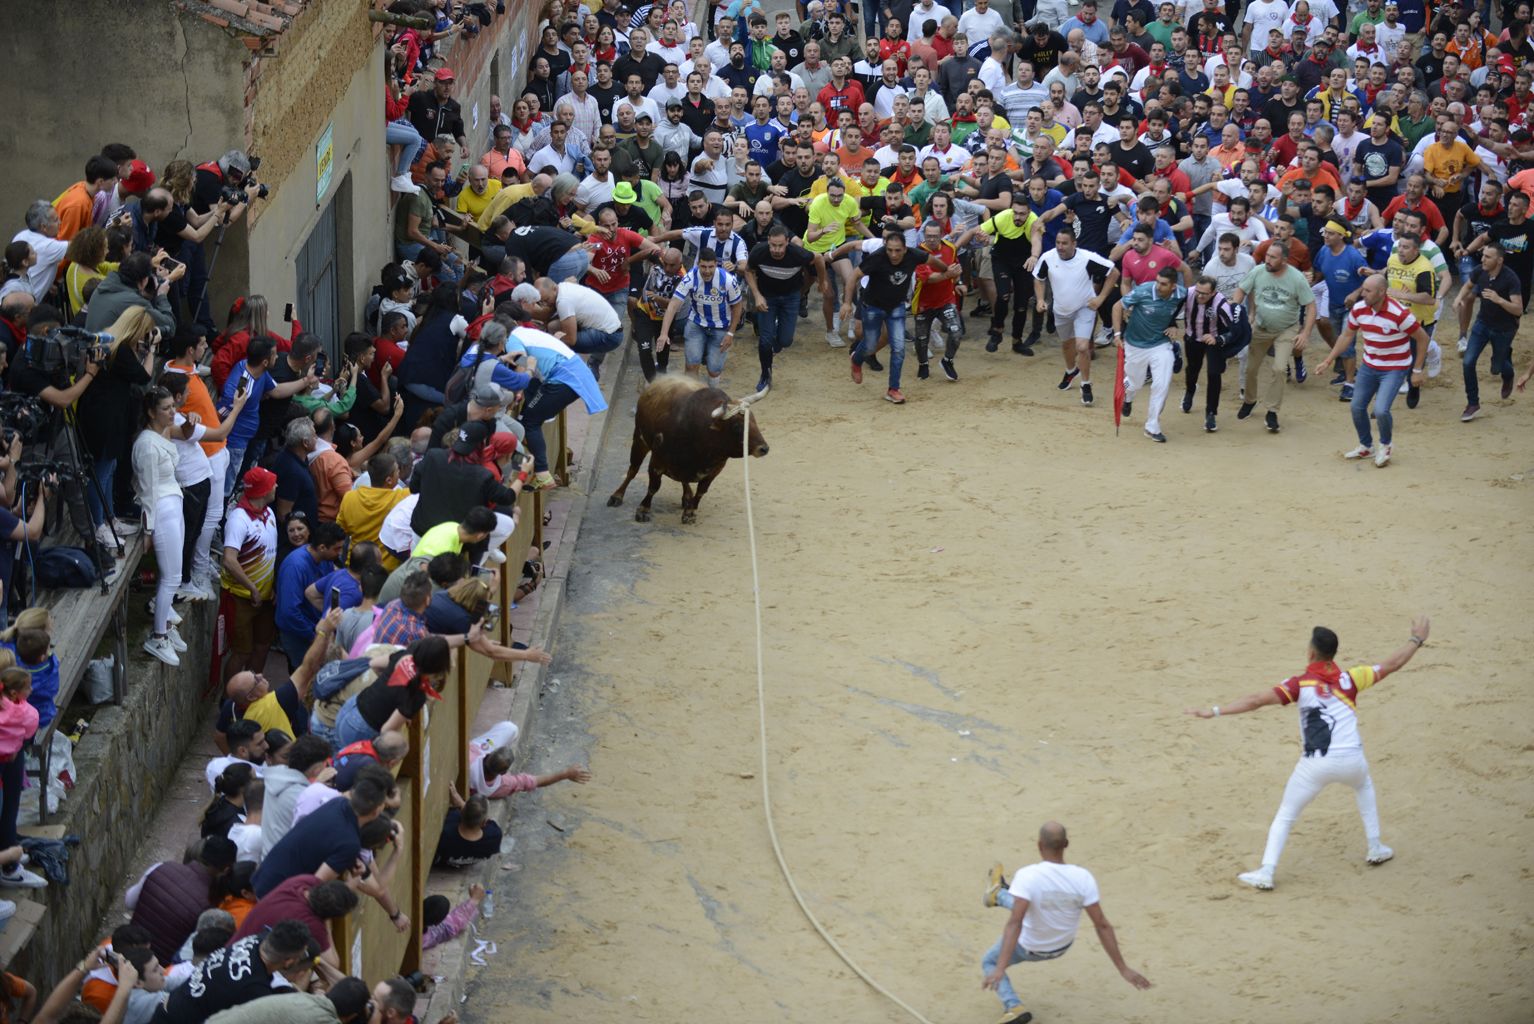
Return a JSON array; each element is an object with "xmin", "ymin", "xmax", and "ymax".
[{"xmin": 133, "ymin": 388, "xmax": 187, "ymax": 665}]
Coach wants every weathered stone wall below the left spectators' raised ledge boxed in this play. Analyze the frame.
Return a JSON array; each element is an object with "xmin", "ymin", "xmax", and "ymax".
[{"xmin": 6, "ymin": 596, "xmax": 215, "ymax": 998}]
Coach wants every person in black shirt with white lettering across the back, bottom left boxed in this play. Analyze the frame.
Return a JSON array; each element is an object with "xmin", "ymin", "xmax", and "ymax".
[{"xmin": 153, "ymin": 921, "xmax": 319, "ymax": 1024}]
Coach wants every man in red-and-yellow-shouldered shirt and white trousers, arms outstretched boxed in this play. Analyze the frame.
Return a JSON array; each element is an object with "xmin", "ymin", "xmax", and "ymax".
[{"xmin": 1187, "ymin": 615, "xmax": 1430, "ymax": 889}]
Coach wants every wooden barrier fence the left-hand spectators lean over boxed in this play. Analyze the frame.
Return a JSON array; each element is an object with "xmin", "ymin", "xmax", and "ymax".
[{"xmin": 331, "ymin": 412, "xmax": 566, "ymax": 983}]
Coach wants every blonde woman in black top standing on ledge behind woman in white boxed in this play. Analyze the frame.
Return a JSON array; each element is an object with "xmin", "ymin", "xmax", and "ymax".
[{"xmin": 75, "ymin": 308, "xmax": 160, "ymax": 546}]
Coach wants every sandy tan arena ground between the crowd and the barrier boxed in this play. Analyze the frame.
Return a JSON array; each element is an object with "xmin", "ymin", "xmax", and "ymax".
[{"xmin": 463, "ymin": 319, "xmax": 1534, "ymax": 1024}]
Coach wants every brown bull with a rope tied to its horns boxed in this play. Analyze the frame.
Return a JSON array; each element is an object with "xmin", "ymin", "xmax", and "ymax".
[{"xmin": 607, "ymin": 376, "xmax": 767, "ymax": 523}]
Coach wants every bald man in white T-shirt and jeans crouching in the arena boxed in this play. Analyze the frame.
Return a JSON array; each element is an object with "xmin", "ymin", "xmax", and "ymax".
[{"xmin": 980, "ymin": 822, "xmax": 1151, "ymax": 1024}]
